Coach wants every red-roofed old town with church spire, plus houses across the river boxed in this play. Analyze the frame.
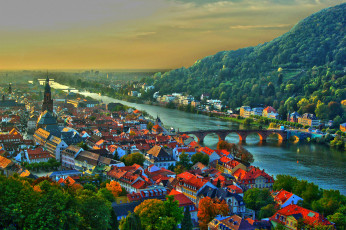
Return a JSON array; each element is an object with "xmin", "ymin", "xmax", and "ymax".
[{"xmin": 0, "ymin": 76, "xmax": 345, "ymax": 229}]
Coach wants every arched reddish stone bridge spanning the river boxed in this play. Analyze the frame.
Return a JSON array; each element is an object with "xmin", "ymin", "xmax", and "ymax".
[{"xmin": 178, "ymin": 129, "xmax": 288, "ymax": 143}]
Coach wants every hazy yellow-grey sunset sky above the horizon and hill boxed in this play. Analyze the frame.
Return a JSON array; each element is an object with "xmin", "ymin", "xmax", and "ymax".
[{"xmin": 0, "ymin": 0, "xmax": 345, "ymax": 70}]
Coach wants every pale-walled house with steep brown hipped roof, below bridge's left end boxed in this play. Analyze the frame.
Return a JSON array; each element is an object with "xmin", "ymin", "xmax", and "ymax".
[{"xmin": 144, "ymin": 145, "xmax": 175, "ymax": 169}]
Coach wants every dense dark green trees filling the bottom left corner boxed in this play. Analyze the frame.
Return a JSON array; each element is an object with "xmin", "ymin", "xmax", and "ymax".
[{"xmin": 0, "ymin": 176, "xmax": 111, "ymax": 229}]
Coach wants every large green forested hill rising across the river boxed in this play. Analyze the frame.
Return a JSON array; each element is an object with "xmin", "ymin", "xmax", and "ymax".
[{"xmin": 144, "ymin": 4, "xmax": 346, "ymax": 119}]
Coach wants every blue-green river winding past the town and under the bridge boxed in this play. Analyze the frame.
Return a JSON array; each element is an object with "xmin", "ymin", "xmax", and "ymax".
[{"xmin": 51, "ymin": 82, "xmax": 346, "ymax": 195}]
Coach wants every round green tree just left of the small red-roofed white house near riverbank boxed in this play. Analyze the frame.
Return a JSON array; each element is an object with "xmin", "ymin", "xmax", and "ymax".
[{"xmin": 244, "ymin": 188, "xmax": 274, "ymax": 212}]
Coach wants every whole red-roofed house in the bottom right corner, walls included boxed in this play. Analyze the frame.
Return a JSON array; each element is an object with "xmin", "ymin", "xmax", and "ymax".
[{"xmin": 270, "ymin": 204, "xmax": 333, "ymax": 230}]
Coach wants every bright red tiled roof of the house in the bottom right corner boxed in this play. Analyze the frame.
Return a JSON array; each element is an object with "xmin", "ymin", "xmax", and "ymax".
[{"xmin": 270, "ymin": 204, "xmax": 332, "ymax": 226}]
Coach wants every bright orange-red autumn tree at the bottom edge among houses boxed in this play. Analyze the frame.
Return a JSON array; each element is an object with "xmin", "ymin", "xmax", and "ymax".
[{"xmin": 197, "ymin": 197, "xmax": 229, "ymax": 230}]
